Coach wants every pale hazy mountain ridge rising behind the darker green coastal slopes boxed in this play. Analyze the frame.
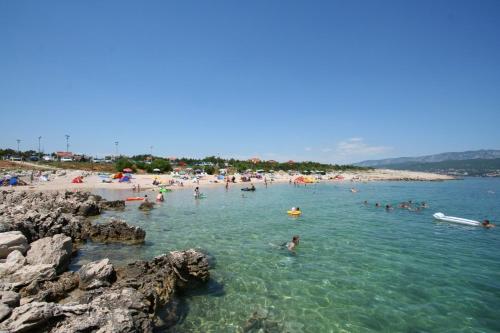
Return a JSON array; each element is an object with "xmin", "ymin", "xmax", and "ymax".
[{"xmin": 354, "ymin": 149, "xmax": 500, "ymax": 168}]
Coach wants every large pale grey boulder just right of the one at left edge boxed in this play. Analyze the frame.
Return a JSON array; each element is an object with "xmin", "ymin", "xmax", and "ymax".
[{"xmin": 26, "ymin": 234, "xmax": 73, "ymax": 273}]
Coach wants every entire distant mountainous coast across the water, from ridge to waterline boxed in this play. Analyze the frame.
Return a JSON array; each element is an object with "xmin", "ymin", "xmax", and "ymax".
[{"xmin": 355, "ymin": 150, "xmax": 500, "ymax": 177}]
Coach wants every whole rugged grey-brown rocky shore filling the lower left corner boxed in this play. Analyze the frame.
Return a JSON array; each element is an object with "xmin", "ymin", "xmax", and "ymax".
[{"xmin": 0, "ymin": 191, "xmax": 210, "ymax": 332}]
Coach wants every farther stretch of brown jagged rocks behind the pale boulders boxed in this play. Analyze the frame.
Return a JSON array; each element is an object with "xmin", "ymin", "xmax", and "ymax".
[{"xmin": 0, "ymin": 190, "xmax": 145, "ymax": 243}]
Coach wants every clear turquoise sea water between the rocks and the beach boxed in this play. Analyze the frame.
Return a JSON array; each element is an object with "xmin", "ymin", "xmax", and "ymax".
[{"xmin": 76, "ymin": 179, "xmax": 500, "ymax": 332}]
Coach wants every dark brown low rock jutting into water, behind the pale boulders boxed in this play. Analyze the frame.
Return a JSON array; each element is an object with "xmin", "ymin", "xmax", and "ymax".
[{"xmin": 89, "ymin": 220, "xmax": 146, "ymax": 244}]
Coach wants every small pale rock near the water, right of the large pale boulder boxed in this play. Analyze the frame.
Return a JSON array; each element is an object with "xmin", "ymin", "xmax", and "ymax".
[{"xmin": 78, "ymin": 258, "xmax": 116, "ymax": 290}]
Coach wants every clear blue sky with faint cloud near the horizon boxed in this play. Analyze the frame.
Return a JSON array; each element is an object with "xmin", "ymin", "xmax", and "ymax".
[{"xmin": 0, "ymin": 0, "xmax": 500, "ymax": 163}]
